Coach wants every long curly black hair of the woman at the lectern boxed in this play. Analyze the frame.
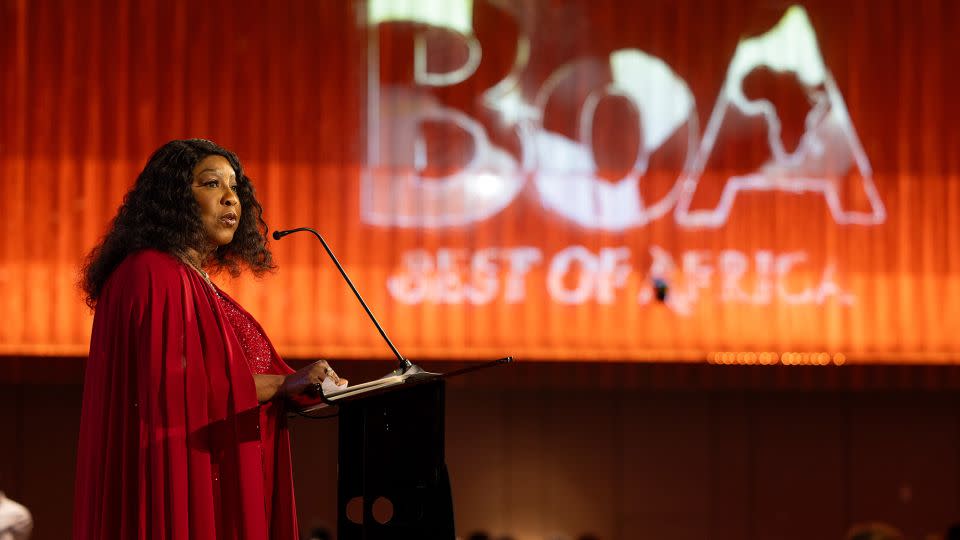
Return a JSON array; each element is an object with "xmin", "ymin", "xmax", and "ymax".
[{"xmin": 80, "ymin": 139, "xmax": 275, "ymax": 307}]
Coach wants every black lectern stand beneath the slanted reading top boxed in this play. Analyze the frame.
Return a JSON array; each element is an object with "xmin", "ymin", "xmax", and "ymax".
[{"xmin": 337, "ymin": 373, "xmax": 455, "ymax": 540}]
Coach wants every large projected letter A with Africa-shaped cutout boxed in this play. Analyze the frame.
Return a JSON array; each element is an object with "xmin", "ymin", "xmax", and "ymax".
[{"xmin": 676, "ymin": 6, "xmax": 886, "ymax": 227}]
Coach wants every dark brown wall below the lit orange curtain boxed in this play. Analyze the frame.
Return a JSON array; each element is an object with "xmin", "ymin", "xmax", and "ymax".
[{"xmin": 0, "ymin": 359, "xmax": 960, "ymax": 540}]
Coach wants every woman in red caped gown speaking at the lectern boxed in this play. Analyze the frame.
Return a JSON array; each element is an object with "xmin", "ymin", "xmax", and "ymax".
[{"xmin": 73, "ymin": 139, "xmax": 346, "ymax": 540}]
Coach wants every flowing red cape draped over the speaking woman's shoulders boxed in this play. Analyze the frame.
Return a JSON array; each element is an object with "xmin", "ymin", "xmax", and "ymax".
[{"xmin": 73, "ymin": 250, "xmax": 298, "ymax": 540}]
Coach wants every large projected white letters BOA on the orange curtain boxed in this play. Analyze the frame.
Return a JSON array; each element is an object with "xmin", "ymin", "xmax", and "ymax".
[{"xmin": 361, "ymin": 0, "xmax": 886, "ymax": 231}]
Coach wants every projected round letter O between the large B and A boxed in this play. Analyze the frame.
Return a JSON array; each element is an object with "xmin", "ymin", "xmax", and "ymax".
[{"xmin": 523, "ymin": 49, "xmax": 697, "ymax": 230}]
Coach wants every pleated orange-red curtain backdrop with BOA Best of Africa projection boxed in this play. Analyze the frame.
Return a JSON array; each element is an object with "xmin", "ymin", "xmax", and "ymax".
[{"xmin": 0, "ymin": 0, "xmax": 960, "ymax": 363}]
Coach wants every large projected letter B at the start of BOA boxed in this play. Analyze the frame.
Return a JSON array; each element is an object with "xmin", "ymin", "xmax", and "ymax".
[{"xmin": 361, "ymin": 0, "xmax": 523, "ymax": 228}]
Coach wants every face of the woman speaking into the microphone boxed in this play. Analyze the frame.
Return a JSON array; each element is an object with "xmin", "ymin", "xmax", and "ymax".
[{"xmin": 192, "ymin": 155, "xmax": 240, "ymax": 249}]
